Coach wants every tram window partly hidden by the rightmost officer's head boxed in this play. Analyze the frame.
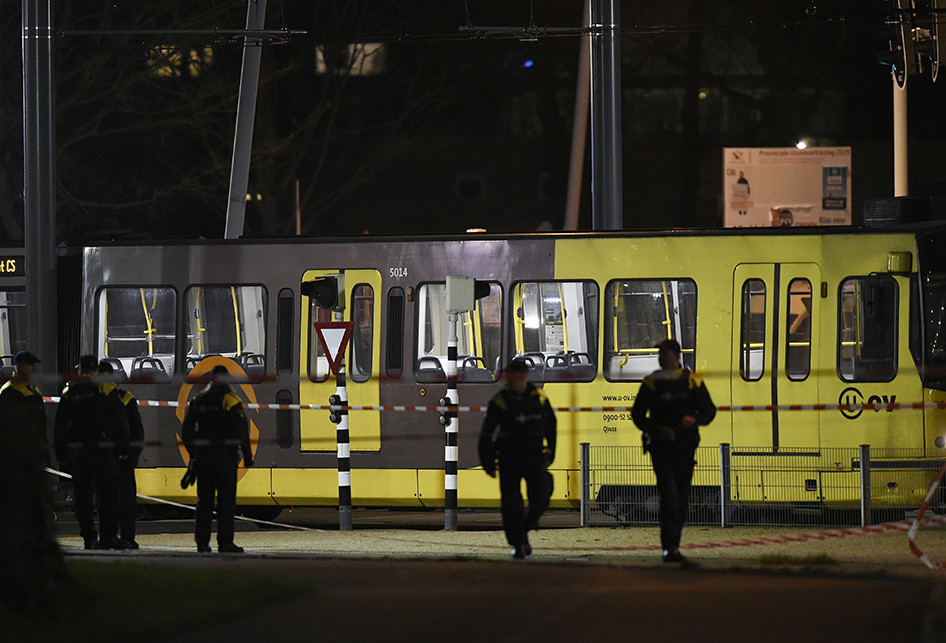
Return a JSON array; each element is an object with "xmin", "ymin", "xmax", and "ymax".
[{"xmin": 604, "ymin": 279, "xmax": 696, "ymax": 381}]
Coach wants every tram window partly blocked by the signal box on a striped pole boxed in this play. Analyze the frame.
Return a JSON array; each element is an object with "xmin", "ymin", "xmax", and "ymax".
[{"xmin": 414, "ymin": 282, "xmax": 502, "ymax": 382}]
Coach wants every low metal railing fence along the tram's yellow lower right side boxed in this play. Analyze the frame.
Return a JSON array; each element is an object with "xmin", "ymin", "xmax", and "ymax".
[{"xmin": 581, "ymin": 443, "xmax": 946, "ymax": 527}]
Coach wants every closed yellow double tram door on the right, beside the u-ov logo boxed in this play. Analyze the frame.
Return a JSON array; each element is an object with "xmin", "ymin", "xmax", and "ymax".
[{"xmin": 731, "ymin": 263, "xmax": 821, "ymax": 452}]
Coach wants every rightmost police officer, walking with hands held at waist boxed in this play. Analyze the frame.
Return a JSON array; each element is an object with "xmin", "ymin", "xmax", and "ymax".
[{"xmin": 631, "ymin": 339, "xmax": 716, "ymax": 563}]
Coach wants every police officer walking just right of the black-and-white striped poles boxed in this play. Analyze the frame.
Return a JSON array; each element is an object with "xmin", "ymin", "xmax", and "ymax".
[{"xmin": 479, "ymin": 359, "xmax": 556, "ymax": 559}]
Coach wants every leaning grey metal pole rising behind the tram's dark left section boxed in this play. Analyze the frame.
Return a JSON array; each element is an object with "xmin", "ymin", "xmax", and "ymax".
[{"xmin": 223, "ymin": 0, "xmax": 266, "ymax": 239}]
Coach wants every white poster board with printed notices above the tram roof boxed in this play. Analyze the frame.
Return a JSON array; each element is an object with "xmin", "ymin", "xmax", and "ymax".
[{"xmin": 723, "ymin": 147, "xmax": 851, "ymax": 228}]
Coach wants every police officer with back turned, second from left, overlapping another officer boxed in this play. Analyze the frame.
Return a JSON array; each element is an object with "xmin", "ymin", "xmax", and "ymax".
[{"xmin": 53, "ymin": 355, "xmax": 130, "ymax": 549}]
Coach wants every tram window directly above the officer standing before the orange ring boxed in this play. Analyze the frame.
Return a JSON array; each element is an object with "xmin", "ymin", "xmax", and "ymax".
[{"xmin": 184, "ymin": 285, "xmax": 268, "ymax": 379}]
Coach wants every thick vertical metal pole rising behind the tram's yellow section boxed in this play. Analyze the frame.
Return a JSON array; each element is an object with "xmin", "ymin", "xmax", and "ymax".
[{"xmin": 590, "ymin": 0, "xmax": 624, "ymax": 230}]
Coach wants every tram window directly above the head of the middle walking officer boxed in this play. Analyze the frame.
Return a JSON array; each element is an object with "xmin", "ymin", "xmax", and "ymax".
[{"xmin": 513, "ymin": 281, "xmax": 598, "ymax": 382}]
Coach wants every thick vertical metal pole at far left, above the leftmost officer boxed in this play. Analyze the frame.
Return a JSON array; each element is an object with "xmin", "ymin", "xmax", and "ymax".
[{"xmin": 22, "ymin": 0, "xmax": 58, "ymax": 372}]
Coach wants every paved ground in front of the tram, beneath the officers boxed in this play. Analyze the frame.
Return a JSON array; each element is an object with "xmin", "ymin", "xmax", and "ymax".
[{"xmin": 58, "ymin": 510, "xmax": 946, "ymax": 643}]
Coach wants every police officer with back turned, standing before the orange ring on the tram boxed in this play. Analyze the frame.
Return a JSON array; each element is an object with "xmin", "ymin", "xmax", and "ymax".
[{"xmin": 181, "ymin": 366, "xmax": 253, "ymax": 554}]
